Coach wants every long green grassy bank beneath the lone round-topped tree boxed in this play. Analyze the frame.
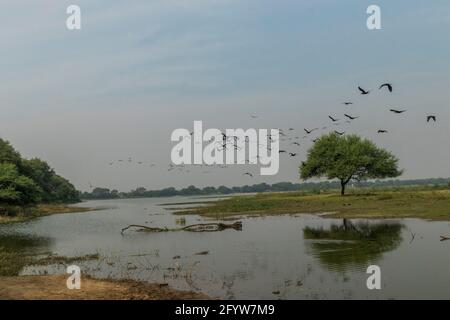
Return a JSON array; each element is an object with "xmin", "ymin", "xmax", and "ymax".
[{"xmin": 177, "ymin": 188, "xmax": 450, "ymax": 220}]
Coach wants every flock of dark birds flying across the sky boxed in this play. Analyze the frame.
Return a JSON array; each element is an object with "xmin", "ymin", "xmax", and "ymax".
[{"xmin": 89, "ymin": 83, "xmax": 437, "ymax": 188}]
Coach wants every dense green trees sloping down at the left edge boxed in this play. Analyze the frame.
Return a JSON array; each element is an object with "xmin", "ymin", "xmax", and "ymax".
[{"xmin": 0, "ymin": 138, "xmax": 80, "ymax": 209}]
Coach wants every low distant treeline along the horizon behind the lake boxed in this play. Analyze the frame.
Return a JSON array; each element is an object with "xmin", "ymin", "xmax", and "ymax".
[{"xmin": 81, "ymin": 178, "xmax": 450, "ymax": 200}]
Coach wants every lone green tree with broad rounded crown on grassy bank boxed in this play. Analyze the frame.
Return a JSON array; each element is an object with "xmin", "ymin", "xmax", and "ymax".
[{"xmin": 300, "ymin": 133, "xmax": 402, "ymax": 195}]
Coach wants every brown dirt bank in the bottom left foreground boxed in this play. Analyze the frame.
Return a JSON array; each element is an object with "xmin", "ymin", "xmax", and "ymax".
[{"xmin": 0, "ymin": 275, "xmax": 208, "ymax": 300}]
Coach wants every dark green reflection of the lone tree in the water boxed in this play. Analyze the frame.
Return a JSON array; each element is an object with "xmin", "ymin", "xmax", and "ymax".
[{"xmin": 303, "ymin": 219, "xmax": 402, "ymax": 271}]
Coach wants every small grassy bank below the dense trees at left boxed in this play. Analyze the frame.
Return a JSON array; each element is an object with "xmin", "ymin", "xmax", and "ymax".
[{"xmin": 0, "ymin": 204, "xmax": 93, "ymax": 224}]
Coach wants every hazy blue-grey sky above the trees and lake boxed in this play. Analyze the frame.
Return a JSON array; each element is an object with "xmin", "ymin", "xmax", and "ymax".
[{"xmin": 0, "ymin": 0, "xmax": 450, "ymax": 191}]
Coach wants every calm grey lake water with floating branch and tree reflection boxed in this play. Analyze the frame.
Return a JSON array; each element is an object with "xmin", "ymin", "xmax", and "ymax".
[{"xmin": 0, "ymin": 196, "xmax": 450, "ymax": 299}]
